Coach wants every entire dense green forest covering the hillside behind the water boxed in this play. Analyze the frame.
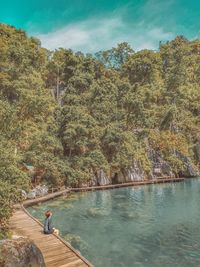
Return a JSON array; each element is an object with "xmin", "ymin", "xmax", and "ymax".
[{"xmin": 0, "ymin": 24, "xmax": 200, "ymax": 236}]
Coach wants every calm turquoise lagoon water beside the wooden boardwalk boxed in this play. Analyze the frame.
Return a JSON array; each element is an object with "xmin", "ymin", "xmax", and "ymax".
[{"xmin": 29, "ymin": 179, "xmax": 200, "ymax": 267}]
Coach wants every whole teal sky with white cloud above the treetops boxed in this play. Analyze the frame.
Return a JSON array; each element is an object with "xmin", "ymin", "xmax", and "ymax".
[{"xmin": 0, "ymin": 0, "xmax": 200, "ymax": 53}]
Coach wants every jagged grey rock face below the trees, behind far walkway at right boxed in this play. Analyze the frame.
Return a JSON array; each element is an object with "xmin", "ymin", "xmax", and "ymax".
[{"xmin": 88, "ymin": 147, "xmax": 200, "ymax": 186}]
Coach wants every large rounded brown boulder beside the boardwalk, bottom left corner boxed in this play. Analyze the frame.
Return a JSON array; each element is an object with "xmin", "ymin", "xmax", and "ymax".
[{"xmin": 0, "ymin": 237, "xmax": 46, "ymax": 267}]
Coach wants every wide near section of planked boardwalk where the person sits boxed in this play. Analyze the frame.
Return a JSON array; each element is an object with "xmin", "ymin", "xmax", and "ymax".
[{"xmin": 10, "ymin": 208, "xmax": 92, "ymax": 267}]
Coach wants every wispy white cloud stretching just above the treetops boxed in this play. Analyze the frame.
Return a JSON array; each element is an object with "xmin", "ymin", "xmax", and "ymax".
[{"xmin": 35, "ymin": 17, "xmax": 173, "ymax": 53}]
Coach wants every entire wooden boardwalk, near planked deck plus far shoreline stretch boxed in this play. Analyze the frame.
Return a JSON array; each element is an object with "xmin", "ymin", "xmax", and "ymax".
[{"xmin": 10, "ymin": 177, "xmax": 184, "ymax": 267}]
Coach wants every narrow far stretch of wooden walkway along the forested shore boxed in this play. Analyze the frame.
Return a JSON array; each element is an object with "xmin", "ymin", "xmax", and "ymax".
[{"xmin": 18, "ymin": 178, "xmax": 185, "ymax": 209}]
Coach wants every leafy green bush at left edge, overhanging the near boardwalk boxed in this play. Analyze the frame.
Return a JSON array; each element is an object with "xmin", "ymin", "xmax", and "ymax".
[{"xmin": 0, "ymin": 136, "xmax": 30, "ymax": 238}]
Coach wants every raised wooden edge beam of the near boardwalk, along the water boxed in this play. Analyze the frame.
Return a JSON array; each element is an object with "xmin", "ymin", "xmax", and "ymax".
[{"xmin": 21, "ymin": 205, "xmax": 94, "ymax": 267}]
